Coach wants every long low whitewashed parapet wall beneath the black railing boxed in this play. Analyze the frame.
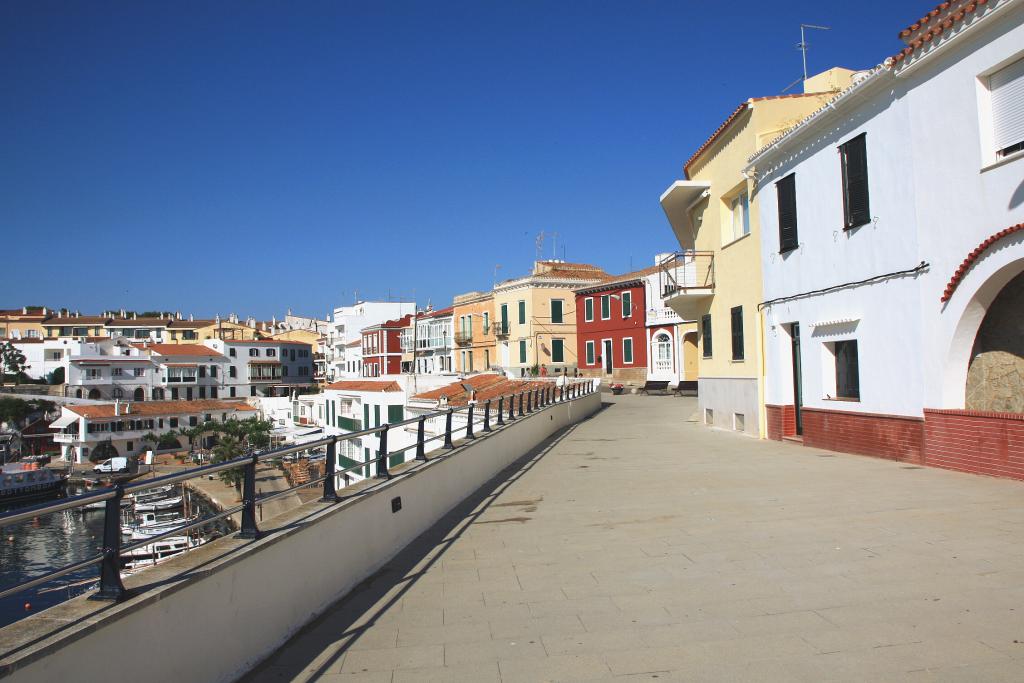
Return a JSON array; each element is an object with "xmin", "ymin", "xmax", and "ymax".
[{"xmin": 0, "ymin": 392, "xmax": 601, "ymax": 683}]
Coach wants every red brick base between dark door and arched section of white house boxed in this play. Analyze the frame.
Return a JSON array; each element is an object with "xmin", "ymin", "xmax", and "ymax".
[{"xmin": 801, "ymin": 408, "xmax": 925, "ymax": 465}]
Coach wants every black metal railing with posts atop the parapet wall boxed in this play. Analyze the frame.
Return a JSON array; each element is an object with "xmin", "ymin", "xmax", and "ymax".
[{"xmin": 0, "ymin": 380, "xmax": 597, "ymax": 600}]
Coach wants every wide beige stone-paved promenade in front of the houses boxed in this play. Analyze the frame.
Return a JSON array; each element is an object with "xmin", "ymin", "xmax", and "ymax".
[{"xmin": 249, "ymin": 396, "xmax": 1024, "ymax": 683}]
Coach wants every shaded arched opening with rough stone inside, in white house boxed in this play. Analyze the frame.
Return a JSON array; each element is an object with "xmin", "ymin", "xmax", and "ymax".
[{"xmin": 965, "ymin": 272, "xmax": 1024, "ymax": 413}]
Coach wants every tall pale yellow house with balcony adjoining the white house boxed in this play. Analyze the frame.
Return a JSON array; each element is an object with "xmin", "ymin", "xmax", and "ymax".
[{"xmin": 662, "ymin": 69, "xmax": 853, "ymax": 436}]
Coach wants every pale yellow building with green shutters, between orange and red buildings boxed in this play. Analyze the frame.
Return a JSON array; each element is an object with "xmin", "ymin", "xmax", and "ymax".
[{"xmin": 494, "ymin": 261, "xmax": 609, "ymax": 377}]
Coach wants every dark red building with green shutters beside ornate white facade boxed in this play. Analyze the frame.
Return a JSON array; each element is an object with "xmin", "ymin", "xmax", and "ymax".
[{"xmin": 575, "ymin": 268, "xmax": 655, "ymax": 384}]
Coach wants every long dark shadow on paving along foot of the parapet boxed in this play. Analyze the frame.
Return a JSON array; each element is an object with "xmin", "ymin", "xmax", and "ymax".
[{"xmin": 239, "ymin": 419, "xmax": 585, "ymax": 683}]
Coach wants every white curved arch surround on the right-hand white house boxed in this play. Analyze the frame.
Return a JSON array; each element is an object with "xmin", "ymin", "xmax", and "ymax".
[{"xmin": 942, "ymin": 259, "xmax": 1024, "ymax": 408}]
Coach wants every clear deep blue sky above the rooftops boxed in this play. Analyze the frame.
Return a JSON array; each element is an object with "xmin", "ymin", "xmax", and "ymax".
[{"xmin": 0, "ymin": 0, "xmax": 930, "ymax": 317}]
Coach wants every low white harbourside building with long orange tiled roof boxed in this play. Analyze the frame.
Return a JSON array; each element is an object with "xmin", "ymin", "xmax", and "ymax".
[{"xmin": 50, "ymin": 399, "xmax": 256, "ymax": 463}]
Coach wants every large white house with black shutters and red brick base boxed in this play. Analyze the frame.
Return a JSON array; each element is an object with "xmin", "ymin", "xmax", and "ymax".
[{"xmin": 748, "ymin": 0, "xmax": 1024, "ymax": 471}]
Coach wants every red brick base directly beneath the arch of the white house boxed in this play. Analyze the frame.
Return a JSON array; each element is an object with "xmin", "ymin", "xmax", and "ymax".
[{"xmin": 925, "ymin": 409, "xmax": 1024, "ymax": 479}]
